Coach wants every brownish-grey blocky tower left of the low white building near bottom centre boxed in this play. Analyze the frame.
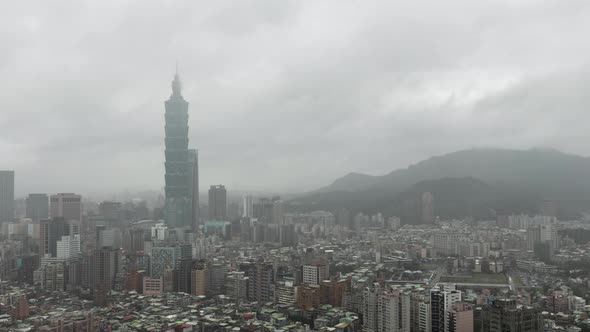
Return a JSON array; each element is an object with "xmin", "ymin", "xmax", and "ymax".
[{"xmin": 240, "ymin": 262, "xmax": 274, "ymax": 302}]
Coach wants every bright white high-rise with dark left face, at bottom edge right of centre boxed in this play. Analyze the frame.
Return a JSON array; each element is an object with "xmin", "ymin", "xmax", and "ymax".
[{"xmin": 430, "ymin": 285, "xmax": 461, "ymax": 332}]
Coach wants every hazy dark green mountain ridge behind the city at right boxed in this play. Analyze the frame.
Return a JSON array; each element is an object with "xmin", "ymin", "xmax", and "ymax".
[{"xmin": 295, "ymin": 149, "xmax": 590, "ymax": 218}]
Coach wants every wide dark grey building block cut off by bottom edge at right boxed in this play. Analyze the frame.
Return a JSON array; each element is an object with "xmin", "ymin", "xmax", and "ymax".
[{"xmin": 481, "ymin": 299, "xmax": 543, "ymax": 332}]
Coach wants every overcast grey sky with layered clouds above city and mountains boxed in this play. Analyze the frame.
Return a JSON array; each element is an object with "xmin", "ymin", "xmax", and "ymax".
[{"xmin": 0, "ymin": 0, "xmax": 590, "ymax": 195}]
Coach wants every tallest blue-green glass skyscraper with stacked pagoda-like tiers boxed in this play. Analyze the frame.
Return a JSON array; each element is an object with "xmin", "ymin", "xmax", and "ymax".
[{"xmin": 164, "ymin": 73, "xmax": 194, "ymax": 227}]
